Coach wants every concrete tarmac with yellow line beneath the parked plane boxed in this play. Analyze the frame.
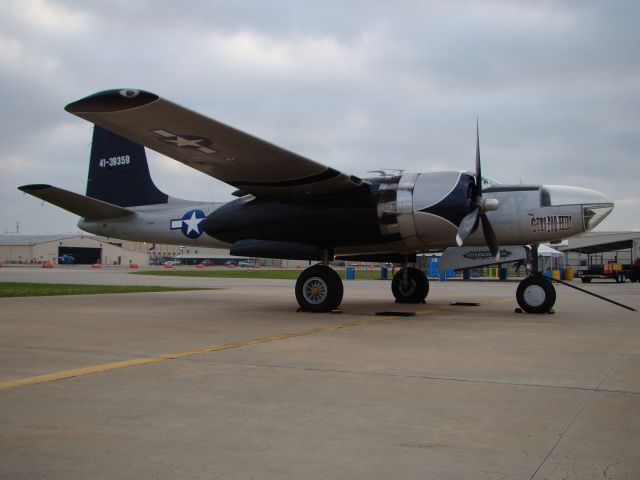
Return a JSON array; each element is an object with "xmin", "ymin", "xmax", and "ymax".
[{"xmin": 0, "ymin": 267, "xmax": 640, "ymax": 480}]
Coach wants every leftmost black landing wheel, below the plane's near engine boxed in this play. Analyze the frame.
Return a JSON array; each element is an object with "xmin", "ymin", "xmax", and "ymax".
[{"xmin": 296, "ymin": 265, "xmax": 344, "ymax": 312}]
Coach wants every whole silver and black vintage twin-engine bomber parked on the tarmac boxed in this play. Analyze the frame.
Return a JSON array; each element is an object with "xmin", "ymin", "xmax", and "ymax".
[{"xmin": 18, "ymin": 89, "xmax": 614, "ymax": 313}]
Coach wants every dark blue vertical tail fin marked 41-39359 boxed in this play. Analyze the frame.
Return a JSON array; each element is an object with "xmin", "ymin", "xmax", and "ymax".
[{"xmin": 87, "ymin": 125, "xmax": 168, "ymax": 207}]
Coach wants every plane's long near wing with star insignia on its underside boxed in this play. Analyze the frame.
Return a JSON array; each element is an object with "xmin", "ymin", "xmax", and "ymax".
[{"xmin": 65, "ymin": 89, "xmax": 365, "ymax": 197}]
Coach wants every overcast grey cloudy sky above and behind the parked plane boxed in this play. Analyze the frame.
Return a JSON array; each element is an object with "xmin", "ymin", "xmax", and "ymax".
[{"xmin": 0, "ymin": 0, "xmax": 640, "ymax": 234}]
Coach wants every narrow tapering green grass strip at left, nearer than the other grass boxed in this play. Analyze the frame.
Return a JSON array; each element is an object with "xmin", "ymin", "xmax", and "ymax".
[{"xmin": 0, "ymin": 282, "xmax": 214, "ymax": 297}]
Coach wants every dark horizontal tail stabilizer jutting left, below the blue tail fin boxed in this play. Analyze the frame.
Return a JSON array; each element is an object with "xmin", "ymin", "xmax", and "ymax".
[{"xmin": 18, "ymin": 184, "xmax": 135, "ymax": 220}]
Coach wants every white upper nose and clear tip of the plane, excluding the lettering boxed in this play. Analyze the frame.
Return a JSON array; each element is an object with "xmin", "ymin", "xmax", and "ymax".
[{"xmin": 542, "ymin": 185, "xmax": 614, "ymax": 232}]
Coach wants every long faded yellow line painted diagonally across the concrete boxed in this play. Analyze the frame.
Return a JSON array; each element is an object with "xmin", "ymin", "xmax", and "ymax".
[{"xmin": 0, "ymin": 299, "xmax": 505, "ymax": 391}]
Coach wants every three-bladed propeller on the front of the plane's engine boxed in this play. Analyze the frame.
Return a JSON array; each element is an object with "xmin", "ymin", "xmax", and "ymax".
[{"xmin": 456, "ymin": 122, "xmax": 500, "ymax": 260}]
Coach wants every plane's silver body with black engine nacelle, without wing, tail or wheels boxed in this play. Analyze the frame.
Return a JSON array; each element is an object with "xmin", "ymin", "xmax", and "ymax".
[{"xmin": 78, "ymin": 171, "xmax": 613, "ymax": 258}]
